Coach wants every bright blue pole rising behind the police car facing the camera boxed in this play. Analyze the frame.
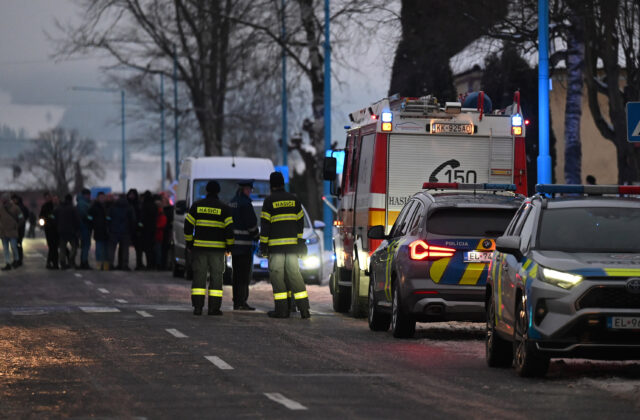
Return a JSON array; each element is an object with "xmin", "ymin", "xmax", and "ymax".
[{"xmin": 538, "ymin": 0, "xmax": 551, "ymax": 184}]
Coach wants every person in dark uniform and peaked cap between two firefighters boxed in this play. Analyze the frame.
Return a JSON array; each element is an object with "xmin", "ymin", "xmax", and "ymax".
[{"xmin": 229, "ymin": 179, "xmax": 258, "ymax": 311}]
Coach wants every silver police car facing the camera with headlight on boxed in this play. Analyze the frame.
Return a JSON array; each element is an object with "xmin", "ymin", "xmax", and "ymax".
[{"xmin": 486, "ymin": 185, "xmax": 640, "ymax": 376}]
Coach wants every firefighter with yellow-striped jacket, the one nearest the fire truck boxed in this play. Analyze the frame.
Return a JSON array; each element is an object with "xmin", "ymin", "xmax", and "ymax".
[{"xmin": 260, "ymin": 172, "xmax": 310, "ymax": 318}]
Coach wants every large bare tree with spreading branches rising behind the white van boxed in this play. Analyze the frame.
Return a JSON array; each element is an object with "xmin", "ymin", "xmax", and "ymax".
[{"xmin": 56, "ymin": 0, "xmax": 268, "ymax": 156}]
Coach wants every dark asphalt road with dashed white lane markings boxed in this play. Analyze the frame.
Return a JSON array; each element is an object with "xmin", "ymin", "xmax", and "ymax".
[{"xmin": 0, "ymin": 240, "xmax": 640, "ymax": 419}]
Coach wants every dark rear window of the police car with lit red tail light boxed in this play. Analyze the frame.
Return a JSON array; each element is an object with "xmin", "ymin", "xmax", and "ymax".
[{"xmin": 427, "ymin": 208, "xmax": 517, "ymax": 237}]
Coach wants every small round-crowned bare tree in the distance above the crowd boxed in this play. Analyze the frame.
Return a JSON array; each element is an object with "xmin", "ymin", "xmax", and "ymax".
[{"xmin": 18, "ymin": 128, "xmax": 104, "ymax": 196}]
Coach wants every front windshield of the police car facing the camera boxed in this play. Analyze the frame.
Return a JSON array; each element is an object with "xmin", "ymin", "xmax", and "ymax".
[{"xmin": 537, "ymin": 207, "xmax": 640, "ymax": 253}]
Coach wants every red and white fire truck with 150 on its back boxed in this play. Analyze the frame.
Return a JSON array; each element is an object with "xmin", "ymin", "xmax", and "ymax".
[{"xmin": 325, "ymin": 94, "xmax": 527, "ymax": 316}]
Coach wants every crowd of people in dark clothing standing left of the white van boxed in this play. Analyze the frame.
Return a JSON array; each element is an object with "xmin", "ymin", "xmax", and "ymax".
[{"xmin": 37, "ymin": 189, "xmax": 173, "ymax": 271}]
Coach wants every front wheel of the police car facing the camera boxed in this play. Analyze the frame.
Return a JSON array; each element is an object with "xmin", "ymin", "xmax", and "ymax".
[{"xmin": 513, "ymin": 300, "xmax": 549, "ymax": 377}]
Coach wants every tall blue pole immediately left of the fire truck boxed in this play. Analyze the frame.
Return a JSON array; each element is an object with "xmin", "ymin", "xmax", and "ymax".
[{"xmin": 322, "ymin": 0, "xmax": 333, "ymax": 251}]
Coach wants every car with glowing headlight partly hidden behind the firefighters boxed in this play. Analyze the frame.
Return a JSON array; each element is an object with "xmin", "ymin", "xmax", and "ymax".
[{"xmin": 253, "ymin": 203, "xmax": 324, "ymax": 284}]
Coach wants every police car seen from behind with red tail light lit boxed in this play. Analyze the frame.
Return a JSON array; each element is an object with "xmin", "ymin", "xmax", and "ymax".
[{"xmin": 368, "ymin": 183, "xmax": 524, "ymax": 338}]
